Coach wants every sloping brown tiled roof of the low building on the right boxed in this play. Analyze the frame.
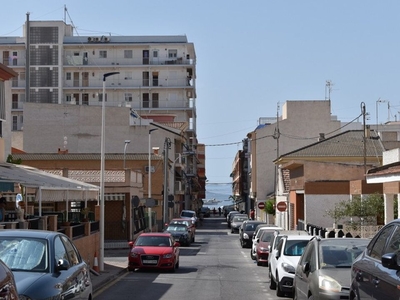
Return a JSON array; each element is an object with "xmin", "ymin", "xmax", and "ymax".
[{"xmin": 275, "ymin": 130, "xmax": 385, "ymax": 162}]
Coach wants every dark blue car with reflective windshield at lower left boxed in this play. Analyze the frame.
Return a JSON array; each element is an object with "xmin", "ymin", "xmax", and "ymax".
[{"xmin": 0, "ymin": 229, "xmax": 93, "ymax": 299}]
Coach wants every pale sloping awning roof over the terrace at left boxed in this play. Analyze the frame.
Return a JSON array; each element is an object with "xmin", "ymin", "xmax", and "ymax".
[{"xmin": 0, "ymin": 163, "xmax": 100, "ymax": 192}]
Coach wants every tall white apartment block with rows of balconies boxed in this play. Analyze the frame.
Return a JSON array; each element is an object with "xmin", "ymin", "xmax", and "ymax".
[{"xmin": 0, "ymin": 18, "xmax": 196, "ymax": 148}]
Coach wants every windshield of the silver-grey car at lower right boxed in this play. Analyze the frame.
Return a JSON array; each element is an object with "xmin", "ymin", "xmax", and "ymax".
[{"xmin": 320, "ymin": 243, "xmax": 367, "ymax": 269}]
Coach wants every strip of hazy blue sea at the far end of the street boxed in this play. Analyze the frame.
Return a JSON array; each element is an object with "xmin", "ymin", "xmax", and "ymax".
[{"xmin": 203, "ymin": 183, "xmax": 233, "ymax": 209}]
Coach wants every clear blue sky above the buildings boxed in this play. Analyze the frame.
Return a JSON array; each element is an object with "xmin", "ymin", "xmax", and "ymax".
[{"xmin": 0, "ymin": 0, "xmax": 400, "ymax": 183}]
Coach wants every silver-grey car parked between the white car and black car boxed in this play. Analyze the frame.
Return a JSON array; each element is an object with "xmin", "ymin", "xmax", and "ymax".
[{"xmin": 293, "ymin": 236, "xmax": 370, "ymax": 300}]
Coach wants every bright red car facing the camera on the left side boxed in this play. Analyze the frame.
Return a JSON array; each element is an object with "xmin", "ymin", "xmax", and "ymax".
[{"xmin": 128, "ymin": 232, "xmax": 180, "ymax": 272}]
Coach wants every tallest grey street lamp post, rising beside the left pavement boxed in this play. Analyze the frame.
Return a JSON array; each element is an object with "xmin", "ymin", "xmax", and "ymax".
[{"xmin": 99, "ymin": 72, "xmax": 119, "ymax": 271}]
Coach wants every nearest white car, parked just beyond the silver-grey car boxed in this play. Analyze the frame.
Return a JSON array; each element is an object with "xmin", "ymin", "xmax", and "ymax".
[{"xmin": 269, "ymin": 234, "xmax": 312, "ymax": 297}]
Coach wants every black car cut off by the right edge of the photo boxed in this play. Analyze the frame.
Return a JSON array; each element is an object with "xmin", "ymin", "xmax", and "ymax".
[{"xmin": 350, "ymin": 219, "xmax": 400, "ymax": 300}]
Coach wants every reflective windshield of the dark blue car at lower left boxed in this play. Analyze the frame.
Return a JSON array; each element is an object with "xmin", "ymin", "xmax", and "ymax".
[{"xmin": 0, "ymin": 237, "xmax": 48, "ymax": 272}]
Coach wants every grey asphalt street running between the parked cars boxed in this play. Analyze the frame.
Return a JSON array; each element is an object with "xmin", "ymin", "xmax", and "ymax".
[{"xmin": 95, "ymin": 217, "xmax": 289, "ymax": 300}]
